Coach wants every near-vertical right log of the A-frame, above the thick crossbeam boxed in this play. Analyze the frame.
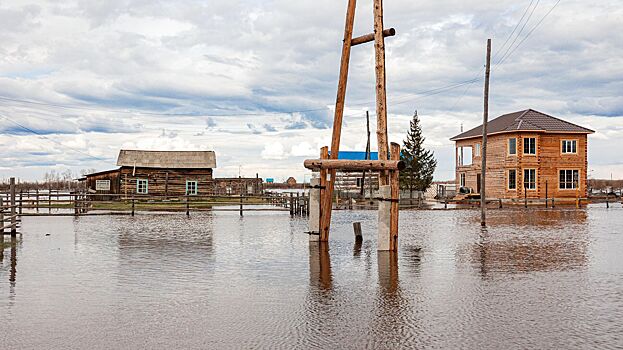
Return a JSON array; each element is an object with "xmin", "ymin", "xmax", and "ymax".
[{"xmin": 374, "ymin": 0, "xmax": 389, "ymax": 186}]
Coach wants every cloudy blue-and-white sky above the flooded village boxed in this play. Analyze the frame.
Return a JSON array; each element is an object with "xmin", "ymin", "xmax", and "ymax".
[{"xmin": 0, "ymin": 0, "xmax": 623, "ymax": 180}]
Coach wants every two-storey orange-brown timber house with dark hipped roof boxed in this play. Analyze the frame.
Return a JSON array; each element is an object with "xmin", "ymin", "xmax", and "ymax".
[{"xmin": 450, "ymin": 109, "xmax": 594, "ymax": 199}]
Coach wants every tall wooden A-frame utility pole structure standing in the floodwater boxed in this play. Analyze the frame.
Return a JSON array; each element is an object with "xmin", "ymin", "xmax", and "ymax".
[{"xmin": 305, "ymin": 0, "xmax": 402, "ymax": 250}]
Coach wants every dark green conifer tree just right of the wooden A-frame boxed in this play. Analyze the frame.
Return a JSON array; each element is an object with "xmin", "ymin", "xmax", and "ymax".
[{"xmin": 400, "ymin": 111, "xmax": 437, "ymax": 198}]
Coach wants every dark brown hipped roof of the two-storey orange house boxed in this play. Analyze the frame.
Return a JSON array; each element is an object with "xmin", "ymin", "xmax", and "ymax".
[{"xmin": 450, "ymin": 109, "xmax": 594, "ymax": 141}]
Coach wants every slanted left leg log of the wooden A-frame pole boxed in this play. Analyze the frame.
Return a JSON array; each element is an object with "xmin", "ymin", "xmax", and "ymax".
[{"xmin": 320, "ymin": 0, "xmax": 358, "ymax": 242}]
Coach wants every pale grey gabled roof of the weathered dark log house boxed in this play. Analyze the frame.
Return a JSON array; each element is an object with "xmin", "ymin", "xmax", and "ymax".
[{"xmin": 117, "ymin": 150, "xmax": 216, "ymax": 169}]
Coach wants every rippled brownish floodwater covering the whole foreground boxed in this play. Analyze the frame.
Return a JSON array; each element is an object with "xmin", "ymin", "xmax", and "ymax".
[{"xmin": 0, "ymin": 204, "xmax": 623, "ymax": 349}]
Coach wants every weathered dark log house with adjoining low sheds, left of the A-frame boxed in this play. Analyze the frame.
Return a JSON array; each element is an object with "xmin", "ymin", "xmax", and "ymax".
[{"xmin": 80, "ymin": 150, "xmax": 263, "ymax": 199}]
